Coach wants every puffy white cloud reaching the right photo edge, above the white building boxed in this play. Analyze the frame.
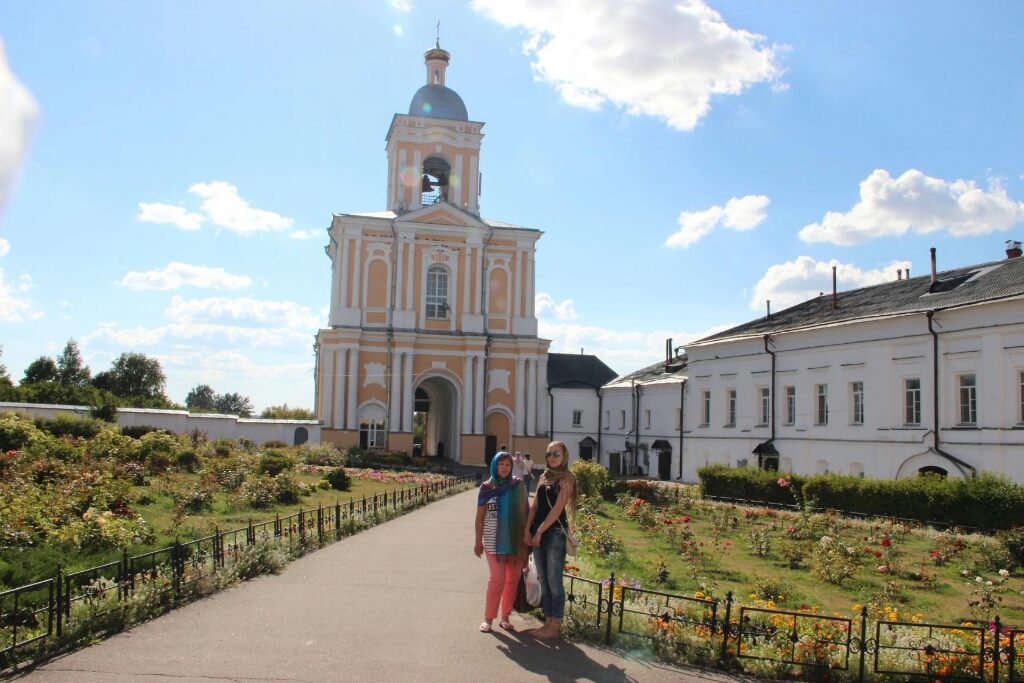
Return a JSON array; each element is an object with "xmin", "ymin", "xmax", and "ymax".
[{"xmin": 800, "ymin": 169, "xmax": 1024, "ymax": 246}]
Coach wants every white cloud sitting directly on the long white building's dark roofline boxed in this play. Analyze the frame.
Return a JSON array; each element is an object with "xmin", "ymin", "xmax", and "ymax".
[{"xmin": 751, "ymin": 256, "xmax": 911, "ymax": 311}]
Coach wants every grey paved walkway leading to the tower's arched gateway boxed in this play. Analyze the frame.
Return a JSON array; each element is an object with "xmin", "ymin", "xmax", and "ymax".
[{"xmin": 13, "ymin": 492, "xmax": 753, "ymax": 683}]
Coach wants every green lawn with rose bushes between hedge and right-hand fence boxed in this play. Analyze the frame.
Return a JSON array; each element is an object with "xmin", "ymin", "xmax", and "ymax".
[{"xmin": 575, "ymin": 491, "xmax": 1024, "ymax": 626}]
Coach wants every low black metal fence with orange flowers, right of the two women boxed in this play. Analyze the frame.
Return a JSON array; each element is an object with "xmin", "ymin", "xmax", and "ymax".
[{"xmin": 564, "ymin": 573, "xmax": 1024, "ymax": 683}]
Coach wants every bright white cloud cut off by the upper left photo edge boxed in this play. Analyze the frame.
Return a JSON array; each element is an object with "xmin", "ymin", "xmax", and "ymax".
[{"xmin": 0, "ymin": 41, "xmax": 39, "ymax": 211}]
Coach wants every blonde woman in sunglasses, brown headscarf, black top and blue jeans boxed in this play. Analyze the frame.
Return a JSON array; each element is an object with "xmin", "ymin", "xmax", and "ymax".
[{"xmin": 523, "ymin": 441, "xmax": 577, "ymax": 638}]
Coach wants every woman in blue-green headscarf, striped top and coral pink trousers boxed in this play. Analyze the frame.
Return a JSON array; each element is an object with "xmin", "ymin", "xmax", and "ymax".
[{"xmin": 473, "ymin": 452, "xmax": 529, "ymax": 633}]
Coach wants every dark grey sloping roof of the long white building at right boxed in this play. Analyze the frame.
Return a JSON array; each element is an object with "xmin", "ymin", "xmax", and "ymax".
[{"xmin": 688, "ymin": 253, "xmax": 1024, "ymax": 347}]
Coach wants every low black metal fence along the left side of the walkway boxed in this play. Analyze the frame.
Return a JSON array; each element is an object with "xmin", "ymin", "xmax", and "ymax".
[{"xmin": 0, "ymin": 477, "xmax": 472, "ymax": 669}]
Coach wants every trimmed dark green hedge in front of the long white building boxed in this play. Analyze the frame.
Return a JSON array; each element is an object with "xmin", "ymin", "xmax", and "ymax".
[{"xmin": 697, "ymin": 465, "xmax": 1024, "ymax": 530}]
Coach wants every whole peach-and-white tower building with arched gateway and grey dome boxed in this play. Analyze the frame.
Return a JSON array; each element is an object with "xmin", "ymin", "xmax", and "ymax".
[{"xmin": 316, "ymin": 46, "xmax": 550, "ymax": 464}]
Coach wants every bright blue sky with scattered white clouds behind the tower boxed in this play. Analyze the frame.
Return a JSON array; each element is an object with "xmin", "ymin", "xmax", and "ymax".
[{"xmin": 0, "ymin": 0, "xmax": 1024, "ymax": 408}]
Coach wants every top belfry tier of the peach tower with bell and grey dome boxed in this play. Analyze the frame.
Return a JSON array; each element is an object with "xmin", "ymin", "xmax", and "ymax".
[{"xmin": 385, "ymin": 41, "xmax": 483, "ymax": 216}]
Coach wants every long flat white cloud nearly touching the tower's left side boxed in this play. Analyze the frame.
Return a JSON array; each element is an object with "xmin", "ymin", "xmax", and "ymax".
[{"xmin": 164, "ymin": 295, "xmax": 324, "ymax": 332}]
